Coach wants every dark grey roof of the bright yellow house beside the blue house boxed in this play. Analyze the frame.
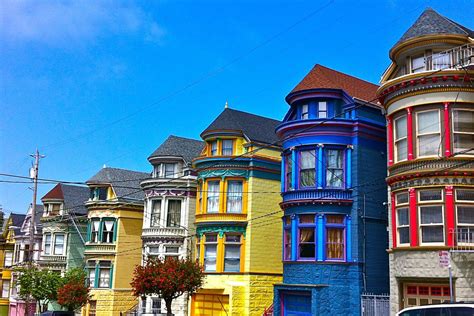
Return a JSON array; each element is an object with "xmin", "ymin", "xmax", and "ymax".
[{"xmin": 201, "ymin": 108, "xmax": 281, "ymax": 144}]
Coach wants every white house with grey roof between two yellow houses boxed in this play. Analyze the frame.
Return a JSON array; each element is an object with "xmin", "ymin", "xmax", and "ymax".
[{"xmin": 139, "ymin": 135, "xmax": 204, "ymax": 316}]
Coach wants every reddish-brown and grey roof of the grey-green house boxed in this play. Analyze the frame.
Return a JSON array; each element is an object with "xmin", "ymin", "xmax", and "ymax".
[{"xmin": 41, "ymin": 183, "xmax": 89, "ymax": 214}]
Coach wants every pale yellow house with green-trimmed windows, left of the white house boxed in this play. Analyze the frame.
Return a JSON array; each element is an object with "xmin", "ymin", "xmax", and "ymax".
[{"xmin": 83, "ymin": 168, "xmax": 149, "ymax": 316}]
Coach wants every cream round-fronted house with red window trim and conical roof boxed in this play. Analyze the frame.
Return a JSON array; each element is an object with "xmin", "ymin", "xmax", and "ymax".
[{"xmin": 378, "ymin": 9, "xmax": 474, "ymax": 313}]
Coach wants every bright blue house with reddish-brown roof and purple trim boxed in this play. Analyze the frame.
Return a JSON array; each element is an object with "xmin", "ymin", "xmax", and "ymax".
[{"xmin": 273, "ymin": 65, "xmax": 389, "ymax": 315}]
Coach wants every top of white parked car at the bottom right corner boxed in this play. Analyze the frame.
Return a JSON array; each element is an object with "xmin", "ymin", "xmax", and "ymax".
[{"xmin": 397, "ymin": 303, "xmax": 474, "ymax": 316}]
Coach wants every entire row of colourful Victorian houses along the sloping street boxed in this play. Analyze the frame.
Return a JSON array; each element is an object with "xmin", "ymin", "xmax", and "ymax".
[{"xmin": 0, "ymin": 9, "xmax": 474, "ymax": 316}]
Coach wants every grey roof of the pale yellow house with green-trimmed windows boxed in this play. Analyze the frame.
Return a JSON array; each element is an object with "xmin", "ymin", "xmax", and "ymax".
[{"xmin": 86, "ymin": 167, "xmax": 150, "ymax": 200}]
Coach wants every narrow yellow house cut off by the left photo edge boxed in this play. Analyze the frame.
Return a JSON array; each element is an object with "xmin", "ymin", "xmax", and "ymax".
[{"xmin": 0, "ymin": 213, "xmax": 25, "ymax": 316}]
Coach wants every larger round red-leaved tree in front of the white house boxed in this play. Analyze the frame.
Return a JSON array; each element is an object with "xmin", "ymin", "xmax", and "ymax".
[{"xmin": 131, "ymin": 258, "xmax": 204, "ymax": 315}]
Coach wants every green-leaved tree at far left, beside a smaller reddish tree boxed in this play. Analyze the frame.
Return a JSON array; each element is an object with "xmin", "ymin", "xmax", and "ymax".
[{"xmin": 16, "ymin": 266, "xmax": 61, "ymax": 312}]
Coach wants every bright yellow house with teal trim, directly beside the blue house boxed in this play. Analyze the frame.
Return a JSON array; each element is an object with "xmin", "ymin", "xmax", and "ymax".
[{"xmin": 190, "ymin": 108, "xmax": 282, "ymax": 316}]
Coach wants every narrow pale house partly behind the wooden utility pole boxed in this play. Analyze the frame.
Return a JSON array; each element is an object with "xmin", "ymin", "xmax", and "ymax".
[{"xmin": 8, "ymin": 204, "xmax": 43, "ymax": 316}]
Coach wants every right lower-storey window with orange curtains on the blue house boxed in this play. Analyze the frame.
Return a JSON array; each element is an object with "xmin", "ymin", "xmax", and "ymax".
[{"xmin": 326, "ymin": 215, "xmax": 345, "ymax": 260}]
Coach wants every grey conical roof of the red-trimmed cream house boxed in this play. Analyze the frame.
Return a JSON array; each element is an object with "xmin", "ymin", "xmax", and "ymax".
[{"xmin": 394, "ymin": 8, "xmax": 474, "ymax": 47}]
